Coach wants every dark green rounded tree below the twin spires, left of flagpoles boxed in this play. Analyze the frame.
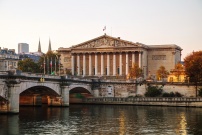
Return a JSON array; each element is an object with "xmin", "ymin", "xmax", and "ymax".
[{"xmin": 18, "ymin": 58, "xmax": 40, "ymax": 73}]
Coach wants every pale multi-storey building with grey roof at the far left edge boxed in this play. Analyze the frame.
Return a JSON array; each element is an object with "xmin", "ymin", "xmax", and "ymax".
[{"xmin": 0, "ymin": 47, "xmax": 20, "ymax": 71}]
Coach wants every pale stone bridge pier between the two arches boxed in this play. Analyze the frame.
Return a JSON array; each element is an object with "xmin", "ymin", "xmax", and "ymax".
[{"xmin": 61, "ymin": 86, "xmax": 69, "ymax": 107}]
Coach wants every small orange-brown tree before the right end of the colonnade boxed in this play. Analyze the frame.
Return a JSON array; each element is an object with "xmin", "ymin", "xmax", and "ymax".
[{"xmin": 129, "ymin": 63, "xmax": 142, "ymax": 79}]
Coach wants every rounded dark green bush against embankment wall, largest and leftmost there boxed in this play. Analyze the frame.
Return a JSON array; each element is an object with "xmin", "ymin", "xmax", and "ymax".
[{"xmin": 145, "ymin": 86, "xmax": 163, "ymax": 97}]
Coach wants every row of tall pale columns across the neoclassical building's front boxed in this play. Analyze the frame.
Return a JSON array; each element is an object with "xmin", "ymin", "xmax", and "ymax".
[{"xmin": 71, "ymin": 51, "xmax": 143, "ymax": 76}]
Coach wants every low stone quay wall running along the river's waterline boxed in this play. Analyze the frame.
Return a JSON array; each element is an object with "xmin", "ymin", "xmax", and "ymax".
[{"xmin": 82, "ymin": 97, "xmax": 202, "ymax": 107}]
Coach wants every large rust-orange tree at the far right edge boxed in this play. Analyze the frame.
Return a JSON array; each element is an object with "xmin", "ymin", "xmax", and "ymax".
[{"xmin": 184, "ymin": 51, "xmax": 202, "ymax": 96}]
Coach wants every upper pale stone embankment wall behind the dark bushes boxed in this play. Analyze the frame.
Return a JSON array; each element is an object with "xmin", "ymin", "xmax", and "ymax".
[{"xmin": 98, "ymin": 83, "xmax": 199, "ymax": 98}]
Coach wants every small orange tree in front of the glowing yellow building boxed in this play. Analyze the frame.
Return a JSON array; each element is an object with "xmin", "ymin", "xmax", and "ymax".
[{"xmin": 171, "ymin": 62, "xmax": 185, "ymax": 82}]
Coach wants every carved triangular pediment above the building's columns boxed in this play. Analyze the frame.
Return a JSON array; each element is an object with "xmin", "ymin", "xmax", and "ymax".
[{"xmin": 72, "ymin": 35, "xmax": 139, "ymax": 49}]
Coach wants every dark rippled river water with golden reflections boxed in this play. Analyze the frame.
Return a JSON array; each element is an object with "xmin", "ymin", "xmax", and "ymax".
[{"xmin": 0, "ymin": 104, "xmax": 202, "ymax": 135}]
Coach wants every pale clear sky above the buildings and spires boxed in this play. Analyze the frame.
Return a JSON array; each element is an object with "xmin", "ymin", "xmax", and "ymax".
[{"xmin": 0, "ymin": 0, "xmax": 202, "ymax": 60}]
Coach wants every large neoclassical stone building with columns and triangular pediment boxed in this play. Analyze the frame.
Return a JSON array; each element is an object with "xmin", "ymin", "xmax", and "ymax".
[{"xmin": 58, "ymin": 34, "xmax": 182, "ymax": 78}]
